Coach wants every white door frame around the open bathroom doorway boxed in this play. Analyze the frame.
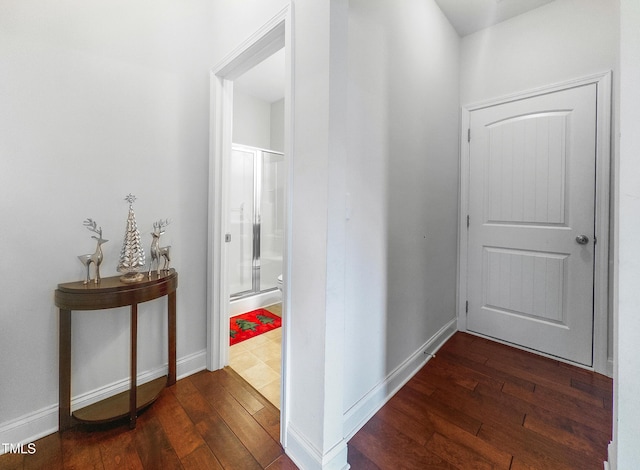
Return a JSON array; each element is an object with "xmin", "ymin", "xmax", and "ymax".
[{"xmin": 206, "ymin": 5, "xmax": 294, "ymax": 447}]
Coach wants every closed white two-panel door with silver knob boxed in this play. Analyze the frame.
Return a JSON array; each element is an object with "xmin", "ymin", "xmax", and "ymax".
[{"xmin": 467, "ymin": 84, "xmax": 596, "ymax": 366}]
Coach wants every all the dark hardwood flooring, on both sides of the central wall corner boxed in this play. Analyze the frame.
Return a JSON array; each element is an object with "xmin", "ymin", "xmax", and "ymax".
[{"xmin": 0, "ymin": 333, "xmax": 612, "ymax": 470}]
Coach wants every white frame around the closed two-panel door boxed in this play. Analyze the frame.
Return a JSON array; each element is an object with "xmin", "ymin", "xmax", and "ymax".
[{"xmin": 456, "ymin": 71, "xmax": 613, "ymax": 377}]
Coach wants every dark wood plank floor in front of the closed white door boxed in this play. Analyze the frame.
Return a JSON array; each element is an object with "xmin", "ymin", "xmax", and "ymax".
[{"xmin": 349, "ymin": 332, "xmax": 612, "ymax": 470}]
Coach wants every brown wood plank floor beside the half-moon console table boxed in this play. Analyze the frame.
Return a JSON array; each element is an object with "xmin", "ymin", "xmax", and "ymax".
[{"xmin": 0, "ymin": 368, "xmax": 297, "ymax": 470}]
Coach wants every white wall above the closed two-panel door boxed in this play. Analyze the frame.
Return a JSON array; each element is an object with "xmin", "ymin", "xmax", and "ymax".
[{"xmin": 460, "ymin": 0, "xmax": 619, "ymax": 360}]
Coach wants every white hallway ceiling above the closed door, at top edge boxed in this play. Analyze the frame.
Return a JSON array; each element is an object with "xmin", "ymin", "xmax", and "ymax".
[{"xmin": 435, "ymin": 0, "xmax": 553, "ymax": 36}]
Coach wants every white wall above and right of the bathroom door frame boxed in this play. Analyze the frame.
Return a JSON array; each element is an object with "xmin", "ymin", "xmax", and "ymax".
[{"xmin": 208, "ymin": 0, "xmax": 346, "ymax": 469}]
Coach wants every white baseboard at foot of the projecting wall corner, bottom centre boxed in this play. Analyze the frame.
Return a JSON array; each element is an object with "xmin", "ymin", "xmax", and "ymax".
[{"xmin": 285, "ymin": 424, "xmax": 350, "ymax": 470}]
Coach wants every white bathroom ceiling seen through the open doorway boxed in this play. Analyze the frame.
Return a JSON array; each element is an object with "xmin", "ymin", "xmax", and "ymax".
[{"xmin": 233, "ymin": 48, "xmax": 285, "ymax": 103}]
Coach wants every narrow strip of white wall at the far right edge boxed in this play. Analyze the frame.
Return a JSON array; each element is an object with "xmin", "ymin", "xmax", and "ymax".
[{"xmin": 609, "ymin": 0, "xmax": 640, "ymax": 470}]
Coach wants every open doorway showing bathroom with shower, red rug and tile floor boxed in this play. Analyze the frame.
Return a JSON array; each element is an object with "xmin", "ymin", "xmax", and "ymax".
[{"xmin": 223, "ymin": 49, "xmax": 286, "ymax": 409}]
